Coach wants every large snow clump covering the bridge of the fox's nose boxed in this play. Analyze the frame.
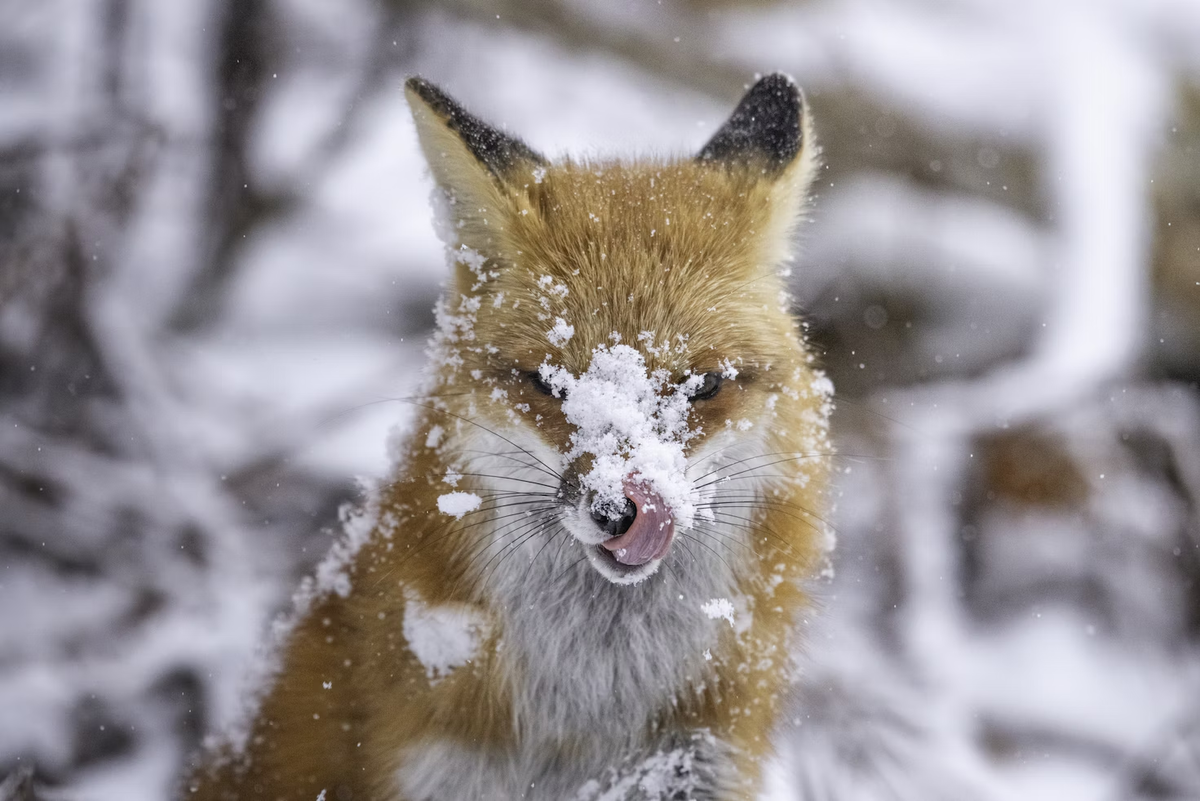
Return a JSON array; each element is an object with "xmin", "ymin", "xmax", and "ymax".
[{"xmin": 539, "ymin": 344, "xmax": 703, "ymax": 528}]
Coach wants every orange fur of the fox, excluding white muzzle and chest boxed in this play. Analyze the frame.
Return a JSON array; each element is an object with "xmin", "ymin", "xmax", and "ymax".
[{"xmin": 184, "ymin": 74, "xmax": 829, "ymax": 801}]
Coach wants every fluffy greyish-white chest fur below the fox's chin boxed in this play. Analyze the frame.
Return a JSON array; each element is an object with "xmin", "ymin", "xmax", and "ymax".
[{"xmin": 396, "ymin": 556, "xmax": 731, "ymax": 801}]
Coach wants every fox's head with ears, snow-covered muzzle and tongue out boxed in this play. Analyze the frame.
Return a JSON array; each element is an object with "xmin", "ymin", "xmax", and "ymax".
[{"xmin": 406, "ymin": 74, "xmax": 828, "ymax": 584}]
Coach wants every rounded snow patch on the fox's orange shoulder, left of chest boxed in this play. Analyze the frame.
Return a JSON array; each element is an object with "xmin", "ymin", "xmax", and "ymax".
[{"xmin": 402, "ymin": 589, "xmax": 488, "ymax": 680}]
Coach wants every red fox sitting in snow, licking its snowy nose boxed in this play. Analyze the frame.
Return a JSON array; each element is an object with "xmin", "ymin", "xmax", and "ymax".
[{"xmin": 182, "ymin": 74, "xmax": 832, "ymax": 801}]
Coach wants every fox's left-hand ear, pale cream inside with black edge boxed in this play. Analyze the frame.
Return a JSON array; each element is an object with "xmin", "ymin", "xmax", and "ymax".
[{"xmin": 404, "ymin": 77, "xmax": 547, "ymax": 249}]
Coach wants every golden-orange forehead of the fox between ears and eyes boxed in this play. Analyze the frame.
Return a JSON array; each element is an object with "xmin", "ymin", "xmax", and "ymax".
[{"xmin": 479, "ymin": 161, "xmax": 792, "ymax": 372}]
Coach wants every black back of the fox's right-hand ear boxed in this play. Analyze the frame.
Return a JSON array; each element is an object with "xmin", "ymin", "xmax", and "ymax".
[{"xmin": 696, "ymin": 72, "xmax": 804, "ymax": 171}]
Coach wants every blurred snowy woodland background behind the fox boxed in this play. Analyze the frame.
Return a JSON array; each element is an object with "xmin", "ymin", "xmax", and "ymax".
[{"xmin": 0, "ymin": 0, "xmax": 1200, "ymax": 801}]
